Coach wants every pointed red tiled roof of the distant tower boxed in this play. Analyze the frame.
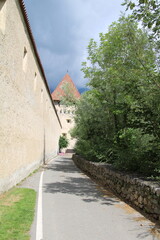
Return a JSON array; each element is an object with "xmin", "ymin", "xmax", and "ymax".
[{"xmin": 51, "ymin": 73, "xmax": 81, "ymax": 100}]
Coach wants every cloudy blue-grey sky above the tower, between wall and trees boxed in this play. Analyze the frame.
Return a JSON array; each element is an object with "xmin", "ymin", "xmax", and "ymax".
[{"xmin": 24, "ymin": 0, "xmax": 125, "ymax": 92}]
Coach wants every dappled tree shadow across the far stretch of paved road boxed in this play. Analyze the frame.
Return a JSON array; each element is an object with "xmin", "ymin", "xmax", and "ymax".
[{"xmin": 44, "ymin": 158, "xmax": 119, "ymax": 205}]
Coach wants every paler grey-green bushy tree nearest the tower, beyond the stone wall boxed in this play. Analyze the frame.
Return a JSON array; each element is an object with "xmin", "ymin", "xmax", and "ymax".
[{"xmin": 72, "ymin": 90, "xmax": 114, "ymax": 161}]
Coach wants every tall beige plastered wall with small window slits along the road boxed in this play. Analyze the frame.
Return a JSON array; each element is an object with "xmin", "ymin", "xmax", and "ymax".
[{"xmin": 0, "ymin": 0, "xmax": 61, "ymax": 192}]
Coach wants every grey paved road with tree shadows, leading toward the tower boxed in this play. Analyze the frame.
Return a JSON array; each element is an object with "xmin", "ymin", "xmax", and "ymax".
[{"xmin": 19, "ymin": 156, "xmax": 160, "ymax": 240}]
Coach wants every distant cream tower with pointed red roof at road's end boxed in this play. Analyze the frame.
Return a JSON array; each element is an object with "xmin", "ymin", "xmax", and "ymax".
[{"xmin": 51, "ymin": 73, "xmax": 80, "ymax": 152}]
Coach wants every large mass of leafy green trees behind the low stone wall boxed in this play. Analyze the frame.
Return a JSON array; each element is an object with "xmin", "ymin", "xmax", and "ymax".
[{"xmin": 72, "ymin": 17, "xmax": 160, "ymax": 175}]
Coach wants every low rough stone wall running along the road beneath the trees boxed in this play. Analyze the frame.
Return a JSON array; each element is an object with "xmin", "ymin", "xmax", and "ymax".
[{"xmin": 73, "ymin": 155, "xmax": 160, "ymax": 220}]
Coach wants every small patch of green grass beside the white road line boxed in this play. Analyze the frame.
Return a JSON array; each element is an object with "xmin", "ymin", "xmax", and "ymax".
[{"xmin": 0, "ymin": 188, "xmax": 36, "ymax": 240}]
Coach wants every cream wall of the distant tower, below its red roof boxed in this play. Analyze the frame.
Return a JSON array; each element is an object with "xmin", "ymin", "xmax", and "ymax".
[{"xmin": 55, "ymin": 101, "xmax": 76, "ymax": 151}]
